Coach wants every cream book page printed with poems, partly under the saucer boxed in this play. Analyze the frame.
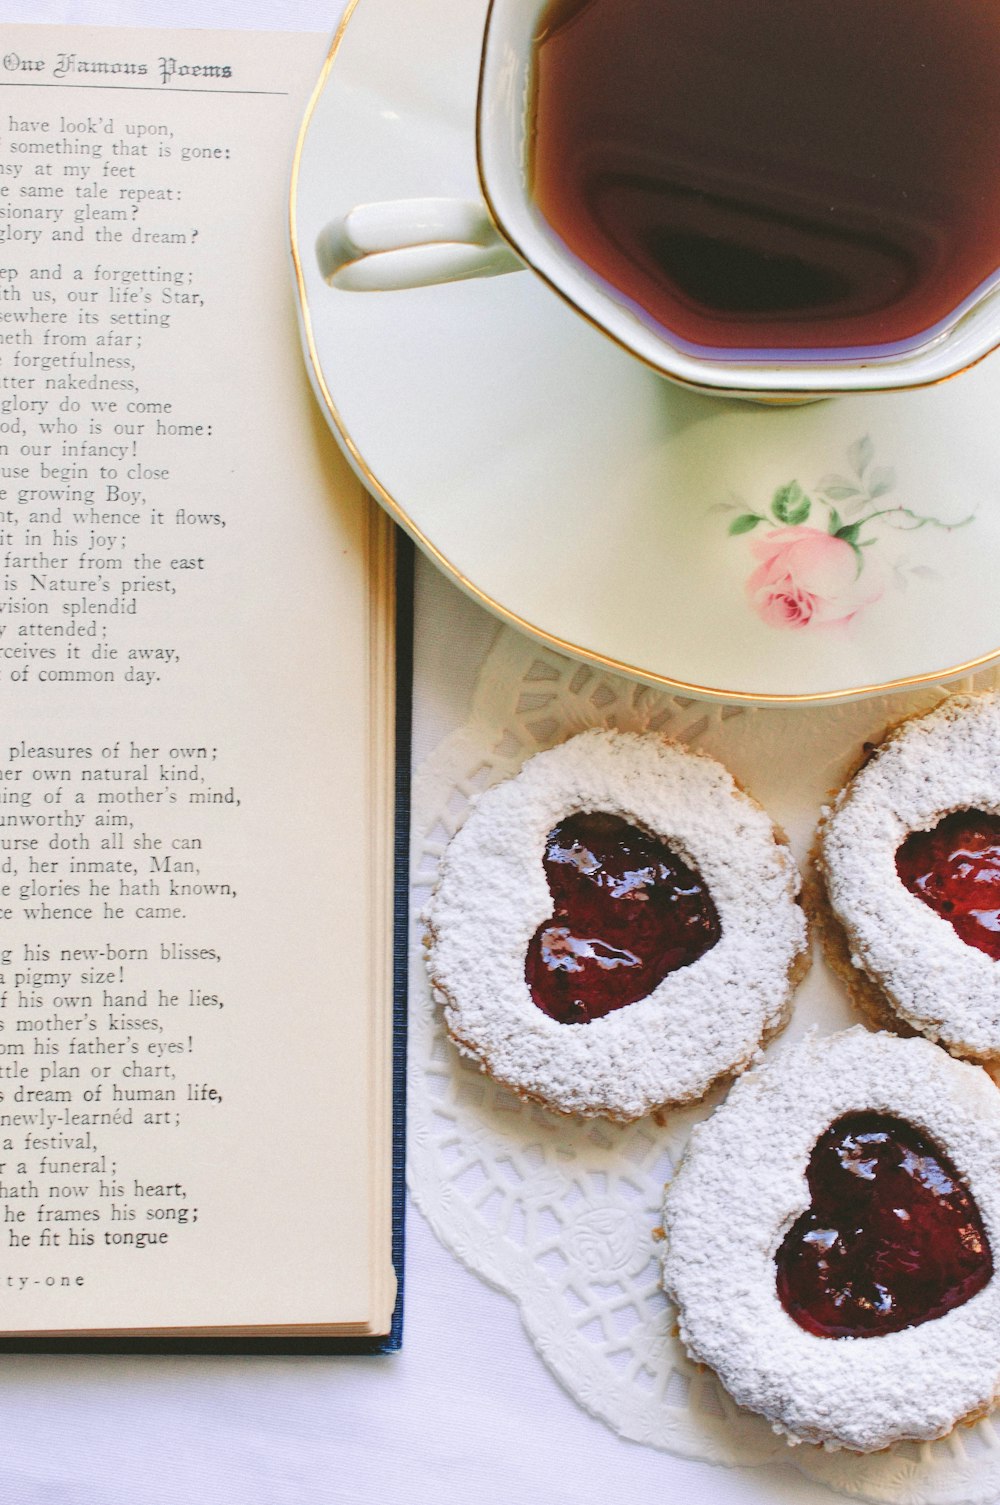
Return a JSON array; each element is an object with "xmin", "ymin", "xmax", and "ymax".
[{"xmin": 0, "ymin": 27, "xmax": 389, "ymax": 1330}]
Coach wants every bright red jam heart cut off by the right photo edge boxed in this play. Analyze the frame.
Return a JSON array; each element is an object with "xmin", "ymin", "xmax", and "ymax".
[{"xmin": 896, "ymin": 810, "xmax": 1000, "ymax": 962}]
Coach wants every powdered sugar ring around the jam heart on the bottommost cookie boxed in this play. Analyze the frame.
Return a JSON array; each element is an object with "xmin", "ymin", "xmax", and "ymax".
[{"xmin": 661, "ymin": 1026, "xmax": 1000, "ymax": 1452}]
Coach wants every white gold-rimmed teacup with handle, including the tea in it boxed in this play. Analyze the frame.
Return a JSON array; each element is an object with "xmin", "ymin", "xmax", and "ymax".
[{"xmin": 318, "ymin": 0, "xmax": 1000, "ymax": 397}]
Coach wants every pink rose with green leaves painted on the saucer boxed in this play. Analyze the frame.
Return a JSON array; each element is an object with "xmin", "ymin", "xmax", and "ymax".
[{"xmin": 709, "ymin": 435, "xmax": 973, "ymax": 628}]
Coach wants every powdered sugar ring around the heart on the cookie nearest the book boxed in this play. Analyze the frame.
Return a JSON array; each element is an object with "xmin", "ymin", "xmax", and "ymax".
[{"xmin": 425, "ymin": 730, "xmax": 806, "ymax": 1120}]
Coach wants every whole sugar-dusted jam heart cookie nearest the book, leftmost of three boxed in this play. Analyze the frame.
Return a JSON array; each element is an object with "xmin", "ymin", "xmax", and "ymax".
[{"xmin": 426, "ymin": 731, "xmax": 806, "ymax": 1121}]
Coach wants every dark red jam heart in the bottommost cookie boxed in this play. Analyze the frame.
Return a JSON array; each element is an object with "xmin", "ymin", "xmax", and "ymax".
[{"xmin": 776, "ymin": 1112, "xmax": 992, "ymax": 1338}]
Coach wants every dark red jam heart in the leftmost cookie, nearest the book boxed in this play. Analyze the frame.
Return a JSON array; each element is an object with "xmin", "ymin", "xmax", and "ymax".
[{"xmin": 524, "ymin": 811, "xmax": 721, "ymax": 1023}]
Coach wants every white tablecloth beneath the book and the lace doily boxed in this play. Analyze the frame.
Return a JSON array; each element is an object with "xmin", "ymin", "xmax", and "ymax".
[{"xmin": 0, "ymin": 0, "xmax": 831, "ymax": 1505}]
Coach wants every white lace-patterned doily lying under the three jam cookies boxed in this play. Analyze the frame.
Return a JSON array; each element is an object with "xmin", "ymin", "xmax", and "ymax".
[{"xmin": 408, "ymin": 628, "xmax": 1000, "ymax": 1505}]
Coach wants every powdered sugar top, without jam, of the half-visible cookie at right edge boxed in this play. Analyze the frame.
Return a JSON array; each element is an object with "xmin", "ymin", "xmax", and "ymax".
[{"xmin": 821, "ymin": 692, "xmax": 1000, "ymax": 1061}]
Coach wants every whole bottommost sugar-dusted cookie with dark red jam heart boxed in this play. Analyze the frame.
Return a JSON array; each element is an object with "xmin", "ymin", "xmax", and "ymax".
[{"xmin": 661, "ymin": 1028, "xmax": 1000, "ymax": 1452}]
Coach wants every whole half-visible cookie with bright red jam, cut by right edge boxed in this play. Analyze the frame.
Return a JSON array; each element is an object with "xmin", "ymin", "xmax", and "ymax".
[{"xmin": 818, "ymin": 692, "xmax": 1000, "ymax": 1063}]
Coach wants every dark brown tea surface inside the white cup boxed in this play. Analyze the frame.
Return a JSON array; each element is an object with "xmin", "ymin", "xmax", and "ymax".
[{"xmin": 532, "ymin": 0, "xmax": 1000, "ymax": 357}]
